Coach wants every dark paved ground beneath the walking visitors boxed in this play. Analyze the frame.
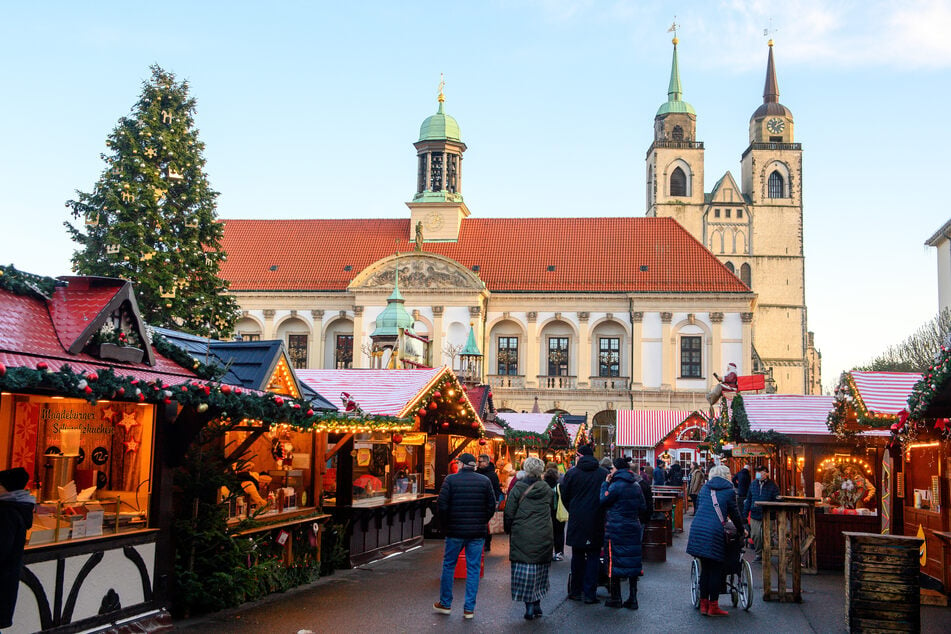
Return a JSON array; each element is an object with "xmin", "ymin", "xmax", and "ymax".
[{"xmin": 177, "ymin": 516, "xmax": 951, "ymax": 634}]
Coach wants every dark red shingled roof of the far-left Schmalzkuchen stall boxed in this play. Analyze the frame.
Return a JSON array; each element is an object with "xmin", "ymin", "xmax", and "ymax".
[{"xmin": 0, "ymin": 290, "xmax": 195, "ymax": 382}]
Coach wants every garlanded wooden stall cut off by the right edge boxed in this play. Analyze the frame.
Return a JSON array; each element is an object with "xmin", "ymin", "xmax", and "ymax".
[{"xmin": 892, "ymin": 356, "xmax": 951, "ymax": 605}]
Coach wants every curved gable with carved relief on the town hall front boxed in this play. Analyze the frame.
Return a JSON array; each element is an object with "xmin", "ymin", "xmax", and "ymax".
[{"xmin": 349, "ymin": 253, "xmax": 485, "ymax": 291}]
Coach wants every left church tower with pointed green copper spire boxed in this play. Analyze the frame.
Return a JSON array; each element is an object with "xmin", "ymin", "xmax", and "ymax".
[{"xmin": 647, "ymin": 37, "xmax": 704, "ymax": 236}]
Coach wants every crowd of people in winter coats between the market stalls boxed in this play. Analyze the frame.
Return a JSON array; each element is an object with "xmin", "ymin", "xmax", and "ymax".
[{"xmin": 433, "ymin": 445, "xmax": 779, "ymax": 620}]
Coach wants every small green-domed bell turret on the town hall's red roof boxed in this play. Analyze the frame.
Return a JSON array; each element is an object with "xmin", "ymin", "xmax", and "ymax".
[{"xmin": 406, "ymin": 82, "xmax": 469, "ymax": 242}]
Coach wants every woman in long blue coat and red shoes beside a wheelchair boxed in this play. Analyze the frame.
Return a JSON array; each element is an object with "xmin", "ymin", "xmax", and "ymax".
[{"xmin": 687, "ymin": 465, "xmax": 744, "ymax": 616}]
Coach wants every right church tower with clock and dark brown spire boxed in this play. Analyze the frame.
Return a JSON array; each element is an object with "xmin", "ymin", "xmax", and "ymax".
[{"xmin": 740, "ymin": 40, "xmax": 810, "ymax": 394}]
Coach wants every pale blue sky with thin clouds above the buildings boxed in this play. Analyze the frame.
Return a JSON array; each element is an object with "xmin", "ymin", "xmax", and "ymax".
[{"xmin": 0, "ymin": 0, "xmax": 951, "ymax": 388}]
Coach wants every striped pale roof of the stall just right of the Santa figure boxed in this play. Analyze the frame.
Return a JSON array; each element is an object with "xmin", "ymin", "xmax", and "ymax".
[{"xmin": 743, "ymin": 394, "xmax": 888, "ymax": 436}]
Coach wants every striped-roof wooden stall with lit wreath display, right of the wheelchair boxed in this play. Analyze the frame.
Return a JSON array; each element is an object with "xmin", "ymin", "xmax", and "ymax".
[{"xmin": 734, "ymin": 394, "xmax": 887, "ymax": 570}]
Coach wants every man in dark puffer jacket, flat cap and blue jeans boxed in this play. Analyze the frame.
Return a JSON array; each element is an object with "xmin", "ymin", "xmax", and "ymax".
[{"xmin": 433, "ymin": 453, "xmax": 496, "ymax": 619}]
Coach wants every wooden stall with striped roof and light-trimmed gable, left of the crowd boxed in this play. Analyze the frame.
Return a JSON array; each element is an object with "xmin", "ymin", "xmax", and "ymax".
[{"xmin": 297, "ymin": 367, "xmax": 487, "ymax": 565}]
